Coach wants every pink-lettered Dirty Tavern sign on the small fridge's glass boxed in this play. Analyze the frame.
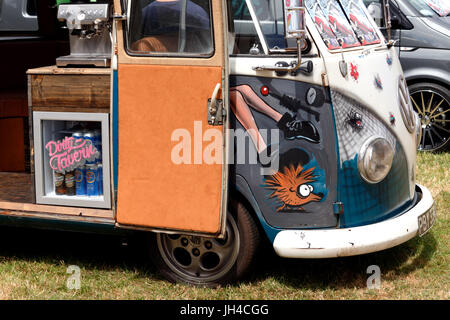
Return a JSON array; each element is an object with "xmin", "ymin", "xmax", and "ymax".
[{"xmin": 45, "ymin": 137, "xmax": 100, "ymax": 173}]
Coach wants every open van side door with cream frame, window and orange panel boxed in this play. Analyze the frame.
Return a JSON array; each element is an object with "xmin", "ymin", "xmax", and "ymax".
[{"xmin": 116, "ymin": 0, "xmax": 228, "ymax": 236}]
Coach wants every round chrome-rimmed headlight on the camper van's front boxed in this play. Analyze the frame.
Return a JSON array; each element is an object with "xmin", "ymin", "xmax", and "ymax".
[{"xmin": 358, "ymin": 137, "xmax": 394, "ymax": 183}]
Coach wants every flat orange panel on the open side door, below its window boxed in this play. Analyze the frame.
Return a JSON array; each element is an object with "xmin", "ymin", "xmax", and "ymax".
[{"xmin": 117, "ymin": 65, "xmax": 222, "ymax": 234}]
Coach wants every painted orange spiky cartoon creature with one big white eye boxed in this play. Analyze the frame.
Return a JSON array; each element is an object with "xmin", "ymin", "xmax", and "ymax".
[{"xmin": 266, "ymin": 165, "xmax": 323, "ymax": 212}]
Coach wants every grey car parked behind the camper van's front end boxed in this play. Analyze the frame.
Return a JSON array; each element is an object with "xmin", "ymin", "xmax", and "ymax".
[{"xmin": 364, "ymin": 0, "xmax": 450, "ymax": 151}]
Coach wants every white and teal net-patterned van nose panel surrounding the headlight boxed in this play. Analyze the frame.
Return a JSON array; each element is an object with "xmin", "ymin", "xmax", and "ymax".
[{"xmin": 331, "ymin": 90, "xmax": 414, "ymax": 228}]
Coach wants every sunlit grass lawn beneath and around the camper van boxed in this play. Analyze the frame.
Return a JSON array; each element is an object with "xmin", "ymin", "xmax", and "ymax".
[{"xmin": 0, "ymin": 153, "xmax": 450, "ymax": 300}]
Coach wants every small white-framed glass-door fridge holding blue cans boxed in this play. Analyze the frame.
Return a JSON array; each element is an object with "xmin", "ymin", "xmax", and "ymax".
[{"xmin": 33, "ymin": 112, "xmax": 111, "ymax": 209}]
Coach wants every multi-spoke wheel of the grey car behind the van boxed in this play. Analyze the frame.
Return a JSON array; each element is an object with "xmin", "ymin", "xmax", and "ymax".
[{"xmin": 409, "ymin": 82, "xmax": 450, "ymax": 151}]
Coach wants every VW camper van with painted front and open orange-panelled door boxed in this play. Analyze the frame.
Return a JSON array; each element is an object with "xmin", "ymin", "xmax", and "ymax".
[{"xmin": 0, "ymin": 0, "xmax": 436, "ymax": 286}]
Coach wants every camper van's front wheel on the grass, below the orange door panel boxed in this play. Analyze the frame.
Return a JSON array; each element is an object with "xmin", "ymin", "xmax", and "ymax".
[{"xmin": 150, "ymin": 203, "xmax": 260, "ymax": 287}]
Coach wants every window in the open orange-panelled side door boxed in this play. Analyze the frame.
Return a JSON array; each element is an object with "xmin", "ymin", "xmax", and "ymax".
[{"xmin": 127, "ymin": 0, "xmax": 214, "ymax": 56}]
